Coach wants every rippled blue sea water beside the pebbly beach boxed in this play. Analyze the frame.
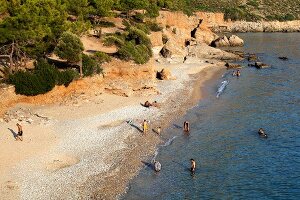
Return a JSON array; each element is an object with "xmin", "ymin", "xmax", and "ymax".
[{"xmin": 123, "ymin": 33, "xmax": 300, "ymax": 199}]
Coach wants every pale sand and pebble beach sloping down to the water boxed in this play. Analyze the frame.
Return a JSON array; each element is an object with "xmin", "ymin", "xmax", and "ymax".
[{"xmin": 0, "ymin": 57, "xmax": 223, "ymax": 199}]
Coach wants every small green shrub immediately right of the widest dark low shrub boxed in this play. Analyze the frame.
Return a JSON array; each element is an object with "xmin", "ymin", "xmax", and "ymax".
[{"xmin": 82, "ymin": 54, "xmax": 102, "ymax": 76}]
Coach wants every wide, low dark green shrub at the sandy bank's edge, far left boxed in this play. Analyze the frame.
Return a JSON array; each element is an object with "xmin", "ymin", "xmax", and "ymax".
[{"xmin": 8, "ymin": 60, "xmax": 78, "ymax": 96}]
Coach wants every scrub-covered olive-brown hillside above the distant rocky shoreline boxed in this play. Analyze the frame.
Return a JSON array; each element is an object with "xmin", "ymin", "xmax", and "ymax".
[{"xmin": 192, "ymin": 0, "xmax": 300, "ymax": 21}]
